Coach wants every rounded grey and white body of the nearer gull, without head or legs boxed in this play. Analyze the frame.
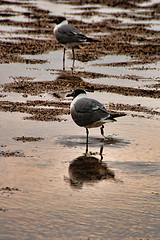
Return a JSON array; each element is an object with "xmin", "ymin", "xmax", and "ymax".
[{"xmin": 71, "ymin": 98, "xmax": 110, "ymax": 126}]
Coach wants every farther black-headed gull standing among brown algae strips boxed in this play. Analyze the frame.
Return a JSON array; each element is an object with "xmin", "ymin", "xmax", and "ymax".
[{"xmin": 53, "ymin": 17, "xmax": 100, "ymax": 69}]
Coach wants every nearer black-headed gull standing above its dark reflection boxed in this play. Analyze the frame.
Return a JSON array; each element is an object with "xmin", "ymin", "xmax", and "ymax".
[{"xmin": 66, "ymin": 89, "xmax": 126, "ymax": 144}]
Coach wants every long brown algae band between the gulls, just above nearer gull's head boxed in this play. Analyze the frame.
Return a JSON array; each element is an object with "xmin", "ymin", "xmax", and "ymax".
[{"xmin": 2, "ymin": 72, "xmax": 160, "ymax": 98}]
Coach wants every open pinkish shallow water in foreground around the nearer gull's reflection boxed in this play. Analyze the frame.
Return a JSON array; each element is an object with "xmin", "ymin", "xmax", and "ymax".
[{"xmin": 0, "ymin": 113, "xmax": 160, "ymax": 239}]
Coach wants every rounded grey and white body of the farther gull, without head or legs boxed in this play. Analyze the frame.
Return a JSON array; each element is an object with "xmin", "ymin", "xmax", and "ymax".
[{"xmin": 55, "ymin": 24, "xmax": 87, "ymax": 44}]
